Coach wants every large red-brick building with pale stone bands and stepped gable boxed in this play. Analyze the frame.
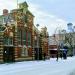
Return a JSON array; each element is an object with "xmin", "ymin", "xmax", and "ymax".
[{"xmin": 0, "ymin": 2, "xmax": 48, "ymax": 62}]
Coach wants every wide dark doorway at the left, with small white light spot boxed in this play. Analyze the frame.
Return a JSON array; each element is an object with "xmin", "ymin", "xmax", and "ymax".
[{"xmin": 3, "ymin": 47, "xmax": 15, "ymax": 63}]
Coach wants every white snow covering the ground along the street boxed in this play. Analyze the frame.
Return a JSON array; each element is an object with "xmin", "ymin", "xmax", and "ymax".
[{"xmin": 0, "ymin": 57, "xmax": 75, "ymax": 75}]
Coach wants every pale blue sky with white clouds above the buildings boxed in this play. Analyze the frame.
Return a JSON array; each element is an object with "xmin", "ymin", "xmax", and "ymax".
[{"xmin": 0, "ymin": 0, "xmax": 75, "ymax": 35}]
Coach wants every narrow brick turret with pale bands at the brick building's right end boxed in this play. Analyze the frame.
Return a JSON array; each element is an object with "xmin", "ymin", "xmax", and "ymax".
[{"xmin": 40, "ymin": 27, "xmax": 49, "ymax": 58}]
